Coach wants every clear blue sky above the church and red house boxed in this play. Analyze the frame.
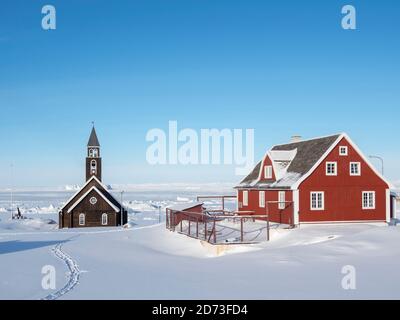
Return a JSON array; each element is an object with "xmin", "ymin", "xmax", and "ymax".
[{"xmin": 0, "ymin": 0, "xmax": 400, "ymax": 187}]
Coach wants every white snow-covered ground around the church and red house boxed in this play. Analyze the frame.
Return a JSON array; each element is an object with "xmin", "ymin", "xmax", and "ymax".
[{"xmin": 0, "ymin": 192, "xmax": 400, "ymax": 299}]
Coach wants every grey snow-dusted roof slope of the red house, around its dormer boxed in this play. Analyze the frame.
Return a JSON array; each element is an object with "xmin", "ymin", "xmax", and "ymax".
[{"xmin": 236, "ymin": 134, "xmax": 340, "ymax": 189}]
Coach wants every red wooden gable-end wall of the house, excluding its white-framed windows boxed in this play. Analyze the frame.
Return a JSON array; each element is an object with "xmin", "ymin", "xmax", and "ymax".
[{"xmin": 299, "ymin": 138, "xmax": 389, "ymax": 222}]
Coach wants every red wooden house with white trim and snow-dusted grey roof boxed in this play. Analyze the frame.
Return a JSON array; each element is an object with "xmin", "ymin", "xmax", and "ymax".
[{"xmin": 236, "ymin": 134, "xmax": 395, "ymax": 225}]
